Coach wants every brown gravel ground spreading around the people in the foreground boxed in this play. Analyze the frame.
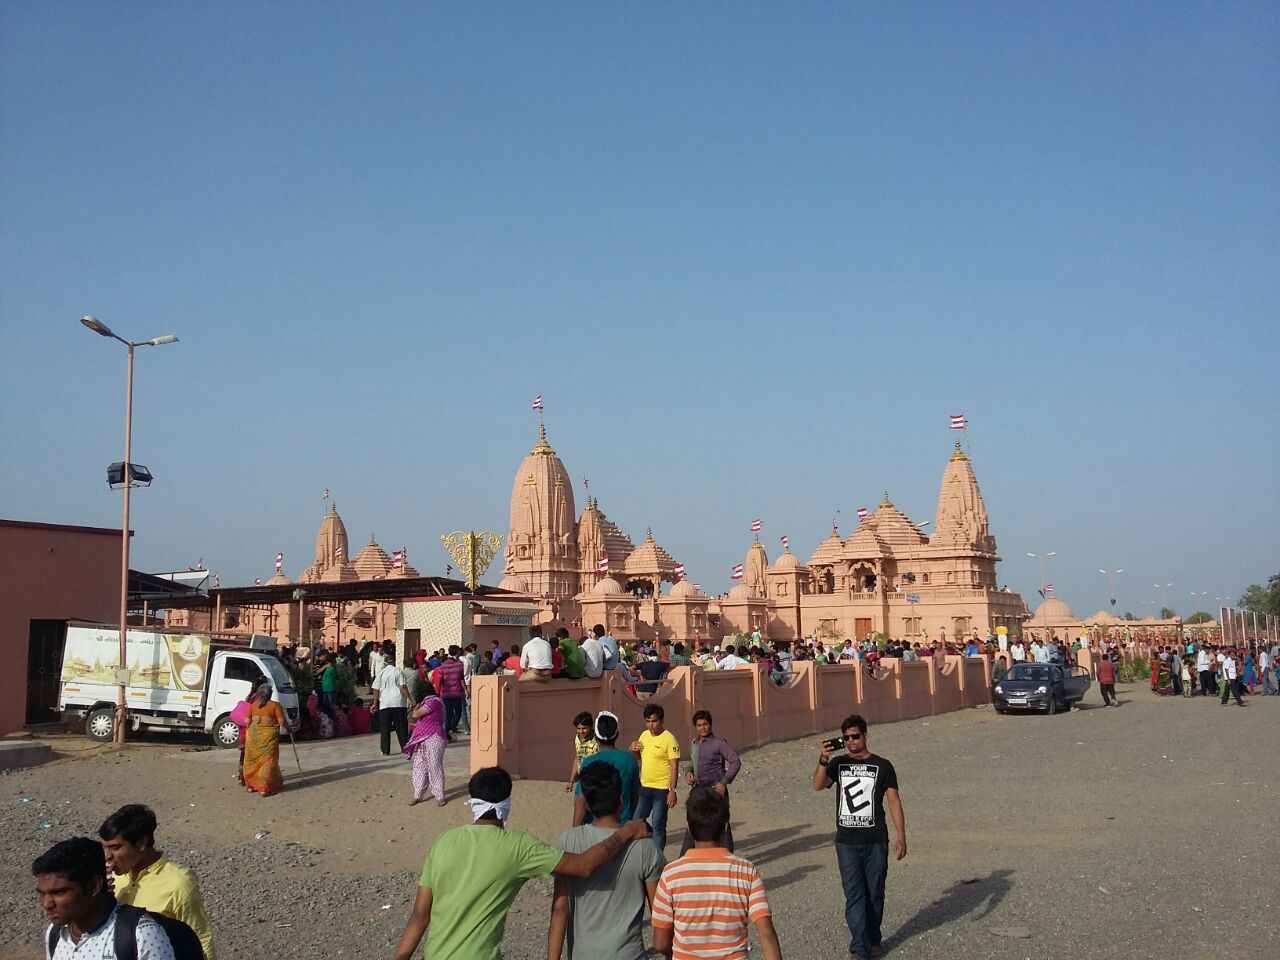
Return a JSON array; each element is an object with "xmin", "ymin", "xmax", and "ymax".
[{"xmin": 0, "ymin": 686, "xmax": 1280, "ymax": 960}]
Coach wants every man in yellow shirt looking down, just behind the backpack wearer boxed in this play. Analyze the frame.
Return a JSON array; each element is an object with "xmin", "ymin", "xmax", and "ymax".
[{"xmin": 97, "ymin": 804, "xmax": 214, "ymax": 960}]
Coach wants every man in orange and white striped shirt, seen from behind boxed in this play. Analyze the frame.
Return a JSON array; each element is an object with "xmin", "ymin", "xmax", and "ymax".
[{"xmin": 653, "ymin": 787, "xmax": 782, "ymax": 960}]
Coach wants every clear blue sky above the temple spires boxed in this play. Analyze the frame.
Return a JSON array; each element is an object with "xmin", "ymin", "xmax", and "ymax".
[{"xmin": 0, "ymin": 0, "xmax": 1280, "ymax": 616}]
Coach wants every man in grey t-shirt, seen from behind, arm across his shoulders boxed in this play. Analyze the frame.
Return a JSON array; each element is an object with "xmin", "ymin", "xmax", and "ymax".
[{"xmin": 547, "ymin": 763, "xmax": 663, "ymax": 960}]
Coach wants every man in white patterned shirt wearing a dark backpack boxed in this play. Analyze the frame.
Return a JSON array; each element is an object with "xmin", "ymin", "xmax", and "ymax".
[{"xmin": 31, "ymin": 837, "xmax": 193, "ymax": 960}]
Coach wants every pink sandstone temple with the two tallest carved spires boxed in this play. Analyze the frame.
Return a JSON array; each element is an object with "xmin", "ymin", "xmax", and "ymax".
[{"xmin": 499, "ymin": 425, "xmax": 1028, "ymax": 643}]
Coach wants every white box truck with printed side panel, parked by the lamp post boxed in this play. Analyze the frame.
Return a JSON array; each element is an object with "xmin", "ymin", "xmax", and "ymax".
[{"xmin": 59, "ymin": 623, "xmax": 300, "ymax": 748}]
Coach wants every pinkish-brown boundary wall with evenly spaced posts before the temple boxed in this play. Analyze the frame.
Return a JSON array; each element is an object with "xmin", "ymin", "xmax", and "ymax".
[{"xmin": 471, "ymin": 657, "xmax": 991, "ymax": 782}]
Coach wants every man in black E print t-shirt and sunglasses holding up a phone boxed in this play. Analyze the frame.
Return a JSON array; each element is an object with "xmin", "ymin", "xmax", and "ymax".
[{"xmin": 813, "ymin": 713, "xmax": 906, "ymax": 959}]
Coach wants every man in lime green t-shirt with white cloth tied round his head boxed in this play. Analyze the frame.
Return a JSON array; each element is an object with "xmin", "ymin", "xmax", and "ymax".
[{"xmin": 396, "ymin": 767, "xmax": 649, "ymax": 960}]
